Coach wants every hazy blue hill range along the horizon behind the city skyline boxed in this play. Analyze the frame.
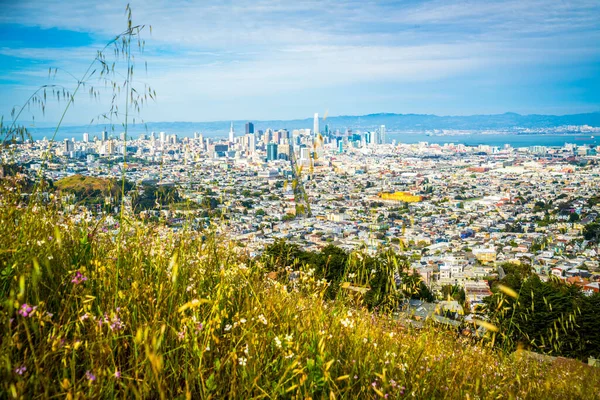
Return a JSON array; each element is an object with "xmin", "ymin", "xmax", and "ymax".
[{"xmin": 23, "ymin": 112, "xmax": 600, "ymax": 140}]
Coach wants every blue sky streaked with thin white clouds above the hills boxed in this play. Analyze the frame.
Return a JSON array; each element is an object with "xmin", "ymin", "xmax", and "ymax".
[{"xmin": 0, "ymin": 0, "xmax": 600, "ymax": 124}]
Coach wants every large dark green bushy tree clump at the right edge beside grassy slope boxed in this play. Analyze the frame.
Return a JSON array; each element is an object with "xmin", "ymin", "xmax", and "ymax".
[{"xmin": 485, "ymin": 268, "xmax": 600, "ymax": 361}]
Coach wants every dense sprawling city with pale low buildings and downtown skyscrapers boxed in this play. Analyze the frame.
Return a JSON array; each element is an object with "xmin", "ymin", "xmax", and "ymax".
[{"xmin": 4, "ymin": 123, "xmax": 600, "ymax": 305}]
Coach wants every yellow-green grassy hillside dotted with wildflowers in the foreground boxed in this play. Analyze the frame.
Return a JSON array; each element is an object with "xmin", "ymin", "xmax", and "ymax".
[{"xmin": 0, "ymin": 183, "xmax": 600, "ymax": 399}]
